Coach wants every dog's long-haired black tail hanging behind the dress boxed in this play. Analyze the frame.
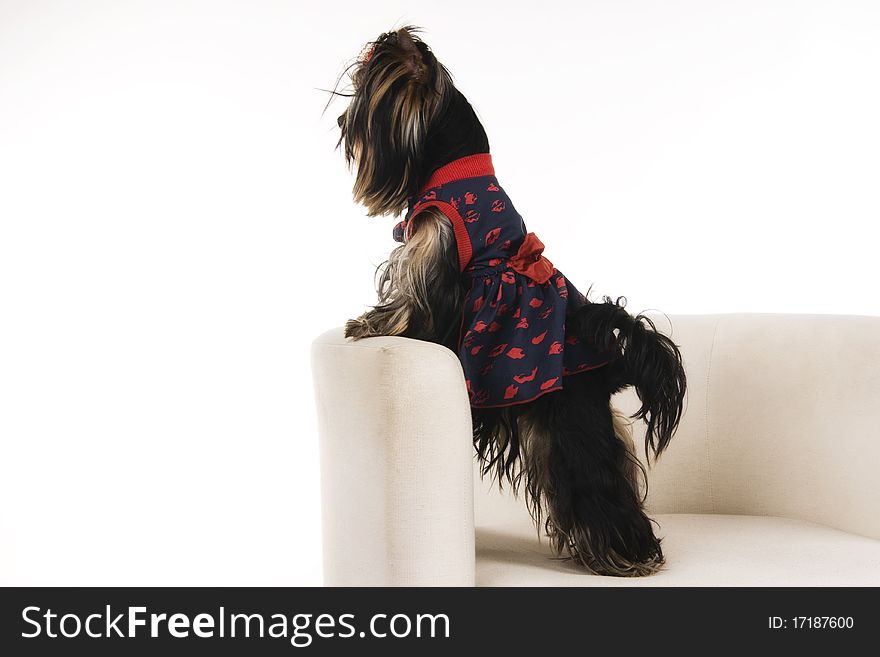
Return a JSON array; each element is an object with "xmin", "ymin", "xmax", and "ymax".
[{"xmin": 570, "ymin": 296, "xmax": 687, "ymax": 461}]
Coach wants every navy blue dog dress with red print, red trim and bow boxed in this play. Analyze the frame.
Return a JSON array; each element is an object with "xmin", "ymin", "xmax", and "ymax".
[{"xmin": 394, "ymin": 153, "xmax": 613, "ymax": 408}]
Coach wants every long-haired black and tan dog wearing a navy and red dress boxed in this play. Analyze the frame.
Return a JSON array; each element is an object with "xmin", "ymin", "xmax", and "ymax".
[{"xmin": 328, "ymin": 26, "xmax": 687, "ymax": 577}]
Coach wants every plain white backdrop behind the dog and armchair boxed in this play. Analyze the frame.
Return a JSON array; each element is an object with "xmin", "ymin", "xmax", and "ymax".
[{"xmin": 0, "ymin": 0, "xmax": 880, "ymax": 585}]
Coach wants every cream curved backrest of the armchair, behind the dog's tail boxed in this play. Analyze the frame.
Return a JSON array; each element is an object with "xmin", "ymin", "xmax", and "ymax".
[{"xmin": 614, "ymin": 313, "xmax": 880, "ymax": 538}]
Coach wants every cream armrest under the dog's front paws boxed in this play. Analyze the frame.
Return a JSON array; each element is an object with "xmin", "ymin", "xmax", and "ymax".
[{"xmin": 312, "ymin": 329, "xmax": 474, "ymax": 586}]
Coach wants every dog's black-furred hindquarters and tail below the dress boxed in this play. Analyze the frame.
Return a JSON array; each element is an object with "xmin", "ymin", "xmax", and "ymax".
[{"xmin": 472, "ymin": 297, "xmax": 687, "ymax": 576}]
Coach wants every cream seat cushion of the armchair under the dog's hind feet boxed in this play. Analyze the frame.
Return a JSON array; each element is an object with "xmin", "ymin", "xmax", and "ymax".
[{"xmin": 476, "ymin": 514, "xmax": 880, "ymax": 586}]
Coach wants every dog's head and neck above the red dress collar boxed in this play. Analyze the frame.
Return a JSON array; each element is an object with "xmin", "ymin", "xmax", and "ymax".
[{"xmin": 337, "ymin": 26, "xmax": 489, "ymax": 216}]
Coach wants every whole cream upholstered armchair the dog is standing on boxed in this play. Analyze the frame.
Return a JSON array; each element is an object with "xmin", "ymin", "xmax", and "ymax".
[{"xmin": 312, "ymin": 314, "xmax": 880, "ymax": 586}]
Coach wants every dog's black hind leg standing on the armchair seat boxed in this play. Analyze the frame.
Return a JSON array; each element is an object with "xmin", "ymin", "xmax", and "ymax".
[{"xmin": 520, "ymin": 368, "xmax": 664, "ymax": 576}]
